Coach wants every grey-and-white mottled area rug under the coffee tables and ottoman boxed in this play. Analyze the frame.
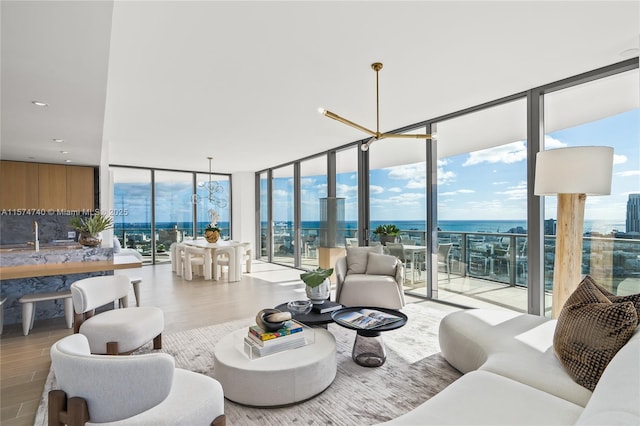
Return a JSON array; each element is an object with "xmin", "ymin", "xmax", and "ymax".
[{"xmin": 35, "ymin": 303, "xmax": 461, "ymax": 426}]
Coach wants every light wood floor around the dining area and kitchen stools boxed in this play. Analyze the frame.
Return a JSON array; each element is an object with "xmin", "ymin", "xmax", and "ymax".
[{"xmin": 0, "ymin": 262, "xmax": 428, "ymax": 426}]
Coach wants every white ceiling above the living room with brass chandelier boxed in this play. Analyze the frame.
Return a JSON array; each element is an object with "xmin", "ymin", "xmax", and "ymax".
[{"xmin": 0, "ymin": 0, "xmax": 640, "ymax": 173}]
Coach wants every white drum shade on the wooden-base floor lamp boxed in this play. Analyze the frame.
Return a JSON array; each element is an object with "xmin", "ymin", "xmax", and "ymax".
[{"xmin": 534, "ymin": 146, "xmax": 613, "ymax": 195}]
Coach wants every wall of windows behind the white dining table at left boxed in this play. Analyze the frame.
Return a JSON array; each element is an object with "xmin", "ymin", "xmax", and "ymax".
[{"xmin": 110, "ymin": 166, "xmax": 231, "ymax": 263}]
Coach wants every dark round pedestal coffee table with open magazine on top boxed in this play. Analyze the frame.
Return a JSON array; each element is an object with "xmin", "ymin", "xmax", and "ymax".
[{"xmin": 332, "ymin": 306, "xmax": 408, "ymax": 367}]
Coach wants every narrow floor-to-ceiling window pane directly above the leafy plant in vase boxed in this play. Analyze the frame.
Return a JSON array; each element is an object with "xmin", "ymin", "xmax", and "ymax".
[{"xmin": 300, "ymin": 155, "xmax": 327, "ymax": 269}]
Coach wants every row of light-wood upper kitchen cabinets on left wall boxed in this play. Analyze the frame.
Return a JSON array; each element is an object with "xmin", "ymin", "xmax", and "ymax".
[{"xmin": 0, "ymin": 161, "xmax": 95, "ymax": 210}]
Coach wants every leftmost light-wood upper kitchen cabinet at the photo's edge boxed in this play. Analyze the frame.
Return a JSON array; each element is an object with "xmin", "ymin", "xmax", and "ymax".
[{"xmin": 0, "ymin": 161, "xmax": 38, "ymax": 209}]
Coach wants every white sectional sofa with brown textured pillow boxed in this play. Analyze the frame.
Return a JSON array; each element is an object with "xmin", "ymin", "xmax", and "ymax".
[{"xmin": 385, "ymin": 309, "xmax": 640, "ymax": 426}]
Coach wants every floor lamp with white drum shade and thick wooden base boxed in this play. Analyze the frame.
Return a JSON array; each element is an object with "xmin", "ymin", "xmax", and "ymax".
[{"xmin": 534, "ymin": 146, "xmax": 613, "ymax": 318}]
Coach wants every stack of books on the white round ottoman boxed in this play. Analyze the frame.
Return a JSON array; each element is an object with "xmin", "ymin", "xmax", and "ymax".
[{"xmin": 244, "ymin": 320, "xmax": 306, "ymax": 359}]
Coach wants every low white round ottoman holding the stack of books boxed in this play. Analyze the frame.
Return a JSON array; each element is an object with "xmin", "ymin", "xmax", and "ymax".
[{"xmin": 213, "ymin": 328, "xmax": 336, "ymax": 407}]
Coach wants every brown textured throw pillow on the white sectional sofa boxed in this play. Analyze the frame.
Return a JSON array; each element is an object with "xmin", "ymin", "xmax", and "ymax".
[{"xmin": 553, "ymin": 276, "xmax": 638, "ymax": 390}]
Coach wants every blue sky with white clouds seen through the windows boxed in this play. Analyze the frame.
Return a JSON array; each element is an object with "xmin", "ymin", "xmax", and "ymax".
[{"xmin": 114, "ymin": 109, "xmax": 640, "ymax": 231}]
